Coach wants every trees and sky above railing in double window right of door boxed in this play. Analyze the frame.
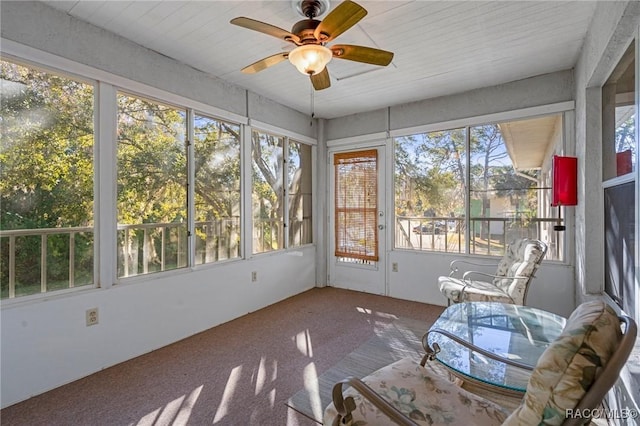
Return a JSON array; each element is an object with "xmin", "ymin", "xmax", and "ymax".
[{"xmin": 394, "ymin": 124, "xmax": 537, "ymax": 223}]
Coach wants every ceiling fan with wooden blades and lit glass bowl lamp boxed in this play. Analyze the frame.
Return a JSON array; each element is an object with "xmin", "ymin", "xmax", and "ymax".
[{"xmin": 231, "ymin": 0, "xmax": 393, "ymax": 90}]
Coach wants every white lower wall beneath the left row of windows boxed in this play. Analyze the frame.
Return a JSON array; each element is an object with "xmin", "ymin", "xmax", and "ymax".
[{"xmin": 1, "ymin": 246, "xmax": 315, "ymax": 407}]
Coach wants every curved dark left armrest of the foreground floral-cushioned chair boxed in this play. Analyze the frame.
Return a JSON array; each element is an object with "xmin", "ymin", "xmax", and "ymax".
[{"xmin": 332, "ymin": 377, "xmax": 418, "ymax": 426}]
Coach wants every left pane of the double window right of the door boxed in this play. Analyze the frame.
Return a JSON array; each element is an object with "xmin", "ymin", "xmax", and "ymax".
[{"xmin": 394, "ymin": 129, "xmax": 467, "ymax": 252}]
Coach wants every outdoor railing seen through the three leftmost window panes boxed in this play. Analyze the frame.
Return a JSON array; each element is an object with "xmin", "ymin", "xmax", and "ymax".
[{"xmin": 0, "ymin": 217, "xmax": 240, "ymax": 299}]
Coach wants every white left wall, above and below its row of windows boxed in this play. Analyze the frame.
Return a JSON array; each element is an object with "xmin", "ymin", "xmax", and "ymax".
[{"xmin": 0, "ymin": 2, "xmax": 316, "ymax": 407}]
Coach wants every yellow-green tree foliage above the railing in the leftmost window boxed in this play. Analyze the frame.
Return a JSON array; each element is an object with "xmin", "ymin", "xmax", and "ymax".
[{"xmin": 0, "ymin": 61, "xmax": 93, "ymax": 229}]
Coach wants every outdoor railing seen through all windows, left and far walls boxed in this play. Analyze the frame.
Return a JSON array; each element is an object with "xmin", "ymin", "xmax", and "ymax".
[{"xmin": 0, "ymin": 216, "xmax": 562, "ymax": 299}]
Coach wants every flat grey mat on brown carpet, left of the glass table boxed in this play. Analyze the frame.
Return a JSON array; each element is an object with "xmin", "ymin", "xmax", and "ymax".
[{"xmin": 286, "ymin": 318, "xmax": 431, "ymax": 424}]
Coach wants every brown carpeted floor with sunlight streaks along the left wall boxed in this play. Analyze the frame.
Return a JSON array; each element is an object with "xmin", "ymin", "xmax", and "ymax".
[{"xmin": 0, "ymin": 288, "xmax": 444, "ymax": 426}]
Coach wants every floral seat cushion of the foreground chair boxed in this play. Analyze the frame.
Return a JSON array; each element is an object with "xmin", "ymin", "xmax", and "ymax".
[{"xmin": 324, "ymin": 358, "xmax": 509, "ymax": 426}]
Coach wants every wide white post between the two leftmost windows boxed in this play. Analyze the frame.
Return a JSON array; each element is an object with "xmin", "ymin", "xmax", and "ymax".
[{"xmin": 94, "ymin": 82, "xmax": 118, "ymax": 288}]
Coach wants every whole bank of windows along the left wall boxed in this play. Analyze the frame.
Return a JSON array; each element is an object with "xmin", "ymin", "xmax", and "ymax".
[{"xmin": 0, "ymin": 53, "xmax": 314, "ymax": 299}]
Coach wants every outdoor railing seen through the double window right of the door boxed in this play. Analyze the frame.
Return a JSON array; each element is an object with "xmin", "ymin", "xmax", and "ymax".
[{"xmin": 394, "ymin": 216, "xmax": 562, "ymax": 260}]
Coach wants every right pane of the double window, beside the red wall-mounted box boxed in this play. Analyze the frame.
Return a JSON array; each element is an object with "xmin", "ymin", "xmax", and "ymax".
[{"xmin": 469, "ymin": 123, "xmax": 561, "ymax": 255}]
